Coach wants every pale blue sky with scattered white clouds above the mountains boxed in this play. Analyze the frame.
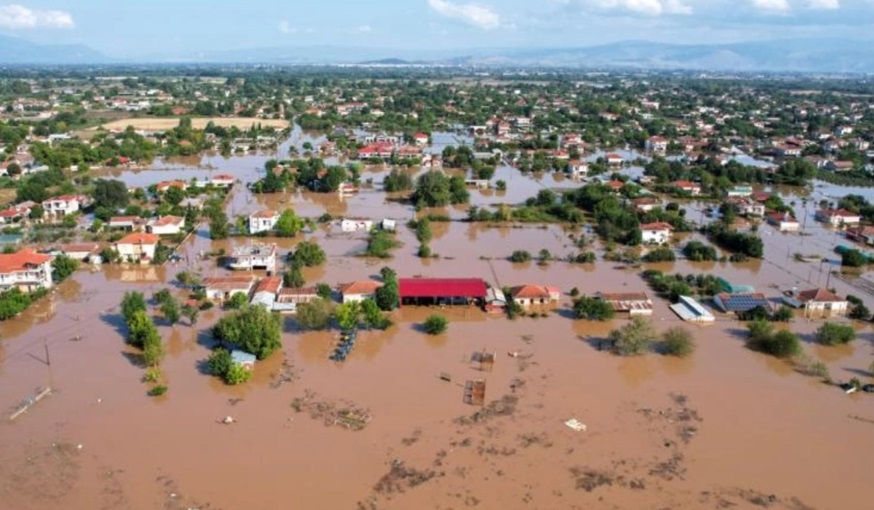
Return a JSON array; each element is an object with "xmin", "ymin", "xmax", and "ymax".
[{"xmin": 0, "ymin": 0, "xmax": 874, "ymax": 57}]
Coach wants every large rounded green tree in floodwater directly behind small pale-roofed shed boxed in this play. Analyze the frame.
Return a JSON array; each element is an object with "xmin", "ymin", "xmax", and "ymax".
[{"xmin": 212, "ymin": 306, "xmax": 282, "ymax": 359}]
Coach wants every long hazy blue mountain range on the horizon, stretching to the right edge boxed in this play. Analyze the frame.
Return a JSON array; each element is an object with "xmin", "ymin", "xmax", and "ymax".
[{"xmin": 156, "ymin": 39, "xmax": 874, "ymax": 73}]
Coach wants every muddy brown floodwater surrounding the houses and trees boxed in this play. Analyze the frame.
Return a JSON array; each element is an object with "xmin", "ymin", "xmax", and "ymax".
[{"xmin": 0, "ymin": 133, "xmax": 874, "ymax": 510}]
